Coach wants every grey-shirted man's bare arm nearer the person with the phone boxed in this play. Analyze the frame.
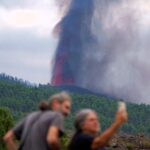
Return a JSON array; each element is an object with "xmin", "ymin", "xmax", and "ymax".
[{"xmin": 47, "ymin": 127, "xmax": 60, "ymax": 150}]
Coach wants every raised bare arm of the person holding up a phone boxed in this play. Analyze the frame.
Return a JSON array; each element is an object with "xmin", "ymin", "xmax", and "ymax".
[{"xmin": 92, "ymin": 113, "xmax": 128, "ymax": 150}]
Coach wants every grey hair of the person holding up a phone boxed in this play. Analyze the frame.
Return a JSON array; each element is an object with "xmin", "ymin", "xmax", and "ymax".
[{"xmin": 68, "ymin": 109, "xmax": 96, "ymax": 150}]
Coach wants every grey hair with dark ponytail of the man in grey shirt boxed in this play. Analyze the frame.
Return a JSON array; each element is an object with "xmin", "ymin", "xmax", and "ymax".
[{"xmin": 39, "ymin": 92, "xmax": 72, "ymax": 111}]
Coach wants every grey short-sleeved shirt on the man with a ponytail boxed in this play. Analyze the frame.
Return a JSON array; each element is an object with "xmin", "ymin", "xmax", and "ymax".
[{"xmin": 13, "ymin": 111, "xmax": 63, "ymax": 150}]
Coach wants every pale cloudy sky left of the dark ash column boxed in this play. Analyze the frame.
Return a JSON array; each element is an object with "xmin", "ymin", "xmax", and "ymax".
[{"xmin": 0, "ymin": 0, "xmax": 59, "ymax": 83}]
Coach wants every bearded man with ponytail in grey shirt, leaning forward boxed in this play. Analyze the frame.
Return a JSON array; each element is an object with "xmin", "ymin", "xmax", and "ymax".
[{"xmin": 4, "ymin": 92, "xmax": 71, "ymax": 150}]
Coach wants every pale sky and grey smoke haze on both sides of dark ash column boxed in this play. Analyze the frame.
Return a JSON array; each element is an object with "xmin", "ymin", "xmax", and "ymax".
[{"xmin": 0, "ymin": 0, "xmax": 150, "ymax": 102}]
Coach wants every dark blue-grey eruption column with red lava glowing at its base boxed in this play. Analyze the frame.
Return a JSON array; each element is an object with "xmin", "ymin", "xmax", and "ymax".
[{"xmin": 52, "ymin": 0, "xmax": 94, "ymax": 85}]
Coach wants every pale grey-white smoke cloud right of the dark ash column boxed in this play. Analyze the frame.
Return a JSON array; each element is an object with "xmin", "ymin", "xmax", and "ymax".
[{"xmin": 83, "ymin": 0, "xmax": 150, "ymax": 103}]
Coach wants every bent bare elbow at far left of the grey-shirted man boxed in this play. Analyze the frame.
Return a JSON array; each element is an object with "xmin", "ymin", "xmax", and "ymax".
[{"xmin": 3, "ymin": 130, "xmax": 17, "ymax": 150}]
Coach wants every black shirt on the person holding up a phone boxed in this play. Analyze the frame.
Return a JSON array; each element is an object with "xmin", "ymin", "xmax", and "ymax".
[{"xmin": 69, "ymin": 134, "xmax": 104, "ymax": 150}]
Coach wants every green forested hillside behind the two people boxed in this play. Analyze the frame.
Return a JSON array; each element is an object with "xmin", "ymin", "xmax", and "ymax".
[{"xmin": 0, "ymin": 74, "xmax": 150, "ymax": 134}]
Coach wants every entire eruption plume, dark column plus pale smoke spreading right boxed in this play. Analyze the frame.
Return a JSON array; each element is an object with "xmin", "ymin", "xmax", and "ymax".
[{"xmin": 51, "ymin": 0, "xmax": 150, "ymax": 103}]
